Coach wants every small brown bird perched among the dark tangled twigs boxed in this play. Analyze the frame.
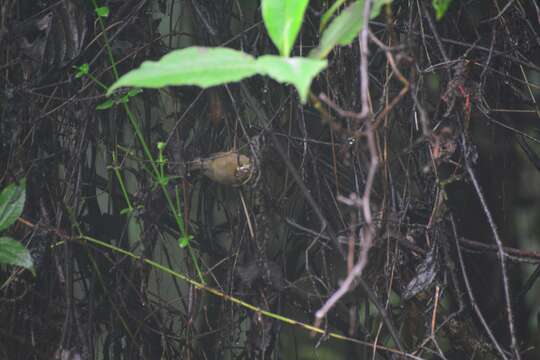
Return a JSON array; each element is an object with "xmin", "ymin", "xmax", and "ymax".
[{"xmin": 189, "ymin": 150, "xmax": 253, "ymax": 186}]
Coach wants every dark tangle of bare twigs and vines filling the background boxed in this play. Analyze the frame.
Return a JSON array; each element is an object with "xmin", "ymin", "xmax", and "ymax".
[{"xmin": 0, "ymin": 0, "xmax": 540, "ymax": 359}]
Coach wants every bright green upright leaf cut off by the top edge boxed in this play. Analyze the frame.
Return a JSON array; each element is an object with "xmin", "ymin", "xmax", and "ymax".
[{"xmin": 262, "ymin": 0, "xmax": 309, "ymax": 56}]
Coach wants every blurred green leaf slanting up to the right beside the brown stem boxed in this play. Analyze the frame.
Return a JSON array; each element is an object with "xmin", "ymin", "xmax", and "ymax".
[{"xmin": 309, "ymin": 0, "xmax": 392, "ymax": 59}]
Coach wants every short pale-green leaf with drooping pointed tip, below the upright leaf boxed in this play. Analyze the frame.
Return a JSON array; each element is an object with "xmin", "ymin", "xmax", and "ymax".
[{"xmin": 257, "ymin": 55, "xmax": 327, "ymax": 103}]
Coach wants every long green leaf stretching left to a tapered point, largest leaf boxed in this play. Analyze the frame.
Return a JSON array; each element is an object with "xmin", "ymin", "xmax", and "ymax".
[{"xmin": 107, "ymin": 47, "xmax": 257, "ymax": 95}]
